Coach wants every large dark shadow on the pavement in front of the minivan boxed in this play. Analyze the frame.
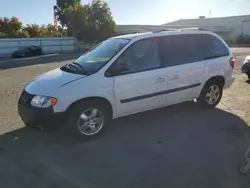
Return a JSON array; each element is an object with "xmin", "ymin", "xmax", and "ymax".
[{"xmin": 0, "ymin": 102, "xmax": 250, "ymax": 188}]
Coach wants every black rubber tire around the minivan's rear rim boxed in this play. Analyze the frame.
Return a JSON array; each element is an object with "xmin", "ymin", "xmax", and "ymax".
[{"xmin": 197, "ymin": 80, "xmax": 223, "ymax": 109}]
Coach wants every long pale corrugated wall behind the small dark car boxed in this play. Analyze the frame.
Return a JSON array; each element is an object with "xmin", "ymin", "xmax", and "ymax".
[{"xmin": 0, "ymin": 37, "xmax": 75, "ymax": 56}]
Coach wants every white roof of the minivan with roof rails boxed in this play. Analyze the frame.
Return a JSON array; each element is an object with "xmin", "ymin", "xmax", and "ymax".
[{"xmin": 112, "ymin": 28, "xmax": 216, "ymax": 39}]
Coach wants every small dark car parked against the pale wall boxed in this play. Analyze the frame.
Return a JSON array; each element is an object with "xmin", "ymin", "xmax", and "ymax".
[{"xmin": 11, "ymin": 46, "xmax": 42, "ymax": 57}]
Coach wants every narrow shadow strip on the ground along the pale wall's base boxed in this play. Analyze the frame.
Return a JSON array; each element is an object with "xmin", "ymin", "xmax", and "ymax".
[{"xmin": 0, "ymin": 53, "xmax": 83, "ymax": 70}]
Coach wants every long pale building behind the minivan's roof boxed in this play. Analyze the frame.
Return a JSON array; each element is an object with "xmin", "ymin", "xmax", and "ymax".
[{"xmin": 117, "ymin": 15, "xmax": 250, "ymax": 44}]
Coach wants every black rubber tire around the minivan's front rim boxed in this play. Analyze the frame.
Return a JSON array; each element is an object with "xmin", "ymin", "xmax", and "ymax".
[{"xmin": 67, "ymin": 100, "xmax": 111, "ymax": 140}]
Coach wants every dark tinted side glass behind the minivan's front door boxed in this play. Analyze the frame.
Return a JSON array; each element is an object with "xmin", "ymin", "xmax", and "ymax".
[{"xmin": 158, "ymin": 34, "xmax": 229, "ymax": 66}]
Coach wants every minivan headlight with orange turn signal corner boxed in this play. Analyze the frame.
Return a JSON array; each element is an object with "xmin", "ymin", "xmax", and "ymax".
[{"xmin": 31, "ymin": 95, "xmax": 57, "ymax": 108}]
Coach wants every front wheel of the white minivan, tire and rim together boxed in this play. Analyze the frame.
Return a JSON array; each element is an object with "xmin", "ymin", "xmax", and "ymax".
[{"xmin": 69, "ymin": 101, "xmax": 111, "ymax": 140}]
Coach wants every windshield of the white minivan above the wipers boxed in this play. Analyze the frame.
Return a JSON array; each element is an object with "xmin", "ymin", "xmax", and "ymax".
[{"xmin": 74, "ymin": 38, "xmax": 130, "ymax": 73}]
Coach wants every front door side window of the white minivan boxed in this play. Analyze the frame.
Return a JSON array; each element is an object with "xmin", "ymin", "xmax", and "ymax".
[{"xmin": 115, "ymin": 39, "xmax": 160, "ymax": 73}]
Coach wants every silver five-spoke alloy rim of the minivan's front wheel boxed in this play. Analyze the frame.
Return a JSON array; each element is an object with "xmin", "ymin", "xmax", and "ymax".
[{"xmin": 77, "ymin": 108, "xmax": 105, "ymax": 136}]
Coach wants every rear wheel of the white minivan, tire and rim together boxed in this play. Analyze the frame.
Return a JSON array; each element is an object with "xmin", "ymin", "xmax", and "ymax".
[{"xmin": 197, "ymin": 81, "xmax": 223, "ymax": 108}]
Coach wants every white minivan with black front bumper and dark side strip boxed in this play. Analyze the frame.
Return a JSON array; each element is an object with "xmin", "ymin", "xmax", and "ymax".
[{"xmin": 18, "ymin": 29, "xmax": 235, "ymax": 139}]
